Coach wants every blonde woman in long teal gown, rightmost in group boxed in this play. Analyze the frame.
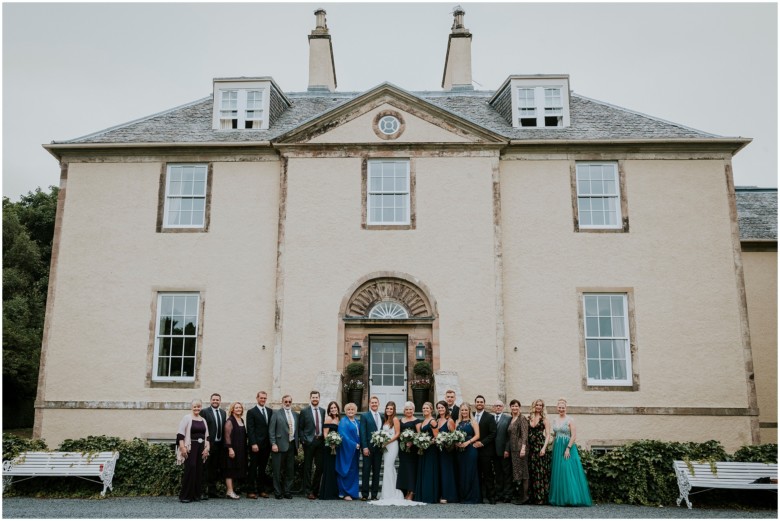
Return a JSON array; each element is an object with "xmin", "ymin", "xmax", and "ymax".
[{"xmin": 548, "ymin": 398, "xmax": 593, "ymax": 507}]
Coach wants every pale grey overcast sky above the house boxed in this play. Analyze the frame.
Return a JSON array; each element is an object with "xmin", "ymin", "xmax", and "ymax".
[{"xmin": 3, "ymin": 2, "xmax": 778, "ymax": 200}]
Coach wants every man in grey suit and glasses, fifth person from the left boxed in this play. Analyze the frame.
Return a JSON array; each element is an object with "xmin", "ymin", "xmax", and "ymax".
[{"xmin": 268, "ymin": 394, "xmax": 300, "ymax": 499}]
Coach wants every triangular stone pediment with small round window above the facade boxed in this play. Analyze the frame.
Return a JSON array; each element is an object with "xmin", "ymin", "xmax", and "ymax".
[{"xmin": 274, "ymin": 83, "xmax": 506, "ymax": 145}]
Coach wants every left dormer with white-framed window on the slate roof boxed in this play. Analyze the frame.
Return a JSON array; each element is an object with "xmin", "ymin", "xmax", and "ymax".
[{"xmin": 212, "ymin": 78, "xmax": 290, "ymax": 130}]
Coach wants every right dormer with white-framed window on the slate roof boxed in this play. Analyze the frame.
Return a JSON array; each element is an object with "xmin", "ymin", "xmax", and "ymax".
[{"xmin": 490, "ymin": 74, "xmax": 570, "ymax": 128}]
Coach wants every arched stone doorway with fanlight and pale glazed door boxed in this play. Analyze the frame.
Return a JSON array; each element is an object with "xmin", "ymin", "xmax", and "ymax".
[{"xmin": 338, "ymin": 272, "xmax": 439, "ymax": 411}]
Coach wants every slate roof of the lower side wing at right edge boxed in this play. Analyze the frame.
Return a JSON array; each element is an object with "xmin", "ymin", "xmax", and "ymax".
[{"xmin": 735, "ymin": 186, "xmax": 777, "ymax": 241}]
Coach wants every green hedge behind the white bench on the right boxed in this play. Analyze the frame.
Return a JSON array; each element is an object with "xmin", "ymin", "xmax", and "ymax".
[{"xmin": 580, "ymin": 440, "xmax": 777, "ymax": 505}]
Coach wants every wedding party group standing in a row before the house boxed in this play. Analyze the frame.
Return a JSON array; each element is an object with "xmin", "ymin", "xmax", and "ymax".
[{"xmin": 176, "ymin": 390, "xmax": 592, "ymax": 506}]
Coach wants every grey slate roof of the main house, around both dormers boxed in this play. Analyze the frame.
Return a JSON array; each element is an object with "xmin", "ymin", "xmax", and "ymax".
[{"xmin": 52, "ymin": 87, "xmax": 720, "ymax": 144}]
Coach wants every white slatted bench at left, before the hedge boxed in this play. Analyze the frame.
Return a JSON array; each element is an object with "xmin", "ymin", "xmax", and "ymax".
[{"xmin": 3, "ymin": 446, "xmax": 119, "ymax": 496}]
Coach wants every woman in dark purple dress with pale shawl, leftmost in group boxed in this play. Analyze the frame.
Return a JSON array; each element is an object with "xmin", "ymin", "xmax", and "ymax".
[{"xmin": 176, "ymin": 400, "xmax": 209, "ymax": 503}]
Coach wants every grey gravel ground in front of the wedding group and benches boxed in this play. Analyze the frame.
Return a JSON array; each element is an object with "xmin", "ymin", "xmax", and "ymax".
[{"xmin": 2, "ymin": 497, "xmax": 777, "ymax": 519}]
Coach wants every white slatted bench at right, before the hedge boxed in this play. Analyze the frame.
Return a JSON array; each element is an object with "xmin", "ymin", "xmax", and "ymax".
[{"xmin": 674, "ymin": 461, "xmax": 777, "ymax": 508}]
